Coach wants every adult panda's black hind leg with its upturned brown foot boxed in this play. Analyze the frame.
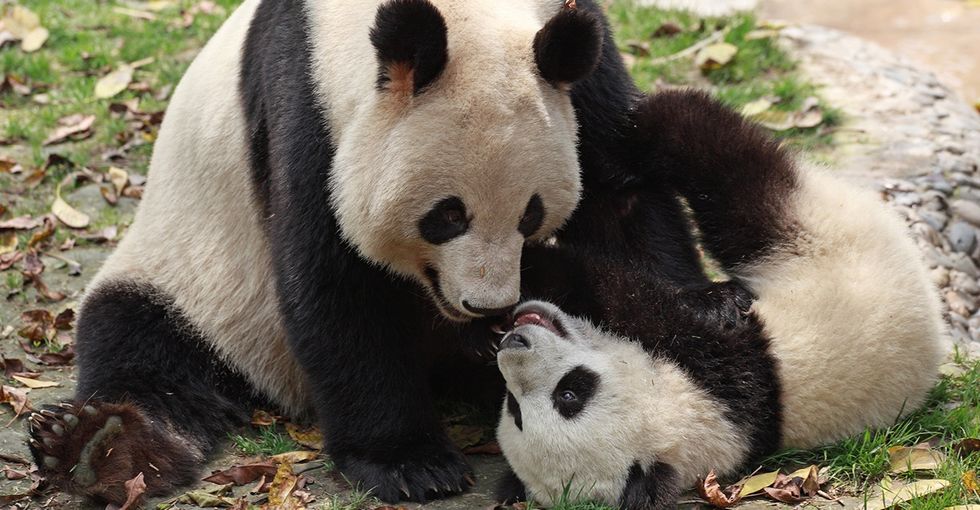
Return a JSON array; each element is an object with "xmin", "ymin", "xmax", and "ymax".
[{"xmin": 29, "ymin": 282, "xmax": 250, "ymax": 504}]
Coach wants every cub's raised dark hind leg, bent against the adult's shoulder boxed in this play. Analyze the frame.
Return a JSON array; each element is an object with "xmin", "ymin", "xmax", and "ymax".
[{"xmin": 632, "ymin": 90, "xmax": 798, "ymax": 269}]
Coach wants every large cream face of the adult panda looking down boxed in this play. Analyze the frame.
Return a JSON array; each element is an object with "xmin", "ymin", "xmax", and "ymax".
[{"xmin": 320, "ymin": 2, "xmax": 581, "ymax": 320}]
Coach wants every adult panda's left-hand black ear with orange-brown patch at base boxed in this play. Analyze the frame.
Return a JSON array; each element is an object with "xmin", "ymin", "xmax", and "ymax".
[{"xmin": 371, "ymin": 0, "xmax": 449, "ymax": 95}]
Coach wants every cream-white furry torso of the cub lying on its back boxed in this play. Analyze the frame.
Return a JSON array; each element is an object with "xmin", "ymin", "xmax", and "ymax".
[{"xmin": 736, "ymin": 170, "xmax": 946, "ymax": 448}]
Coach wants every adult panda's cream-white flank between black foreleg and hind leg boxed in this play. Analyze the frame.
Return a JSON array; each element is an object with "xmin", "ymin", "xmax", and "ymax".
[{"xmin": 89, "ymin": 0, "xmax": 309, "ymax": 413}]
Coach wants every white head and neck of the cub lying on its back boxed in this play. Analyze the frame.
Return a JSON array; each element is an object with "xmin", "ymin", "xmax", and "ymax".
[{"xmin": 497, "ymin": 302, "xmax": 746, "ymax": 505}]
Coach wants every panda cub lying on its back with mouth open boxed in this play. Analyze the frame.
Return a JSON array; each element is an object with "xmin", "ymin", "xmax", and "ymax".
[{"xmin": 497, "ymin": 91, "xmax": 945, "ymax": 509}]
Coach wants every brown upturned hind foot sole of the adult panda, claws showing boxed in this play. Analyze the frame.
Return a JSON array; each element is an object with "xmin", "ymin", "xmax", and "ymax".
[{"xmin": 28, "ymin": 401, "xmax": 193, "ymax": 504}]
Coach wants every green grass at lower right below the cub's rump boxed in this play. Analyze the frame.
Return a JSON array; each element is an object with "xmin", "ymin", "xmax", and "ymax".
[{"xmin": 764, "ymin": 358, "xmax": 980, "ymax": 509}]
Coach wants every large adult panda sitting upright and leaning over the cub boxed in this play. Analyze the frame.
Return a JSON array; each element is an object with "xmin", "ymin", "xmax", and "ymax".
[{"xmin": 24, "ymin": 0, "xmax": 720, "ymax": 503}]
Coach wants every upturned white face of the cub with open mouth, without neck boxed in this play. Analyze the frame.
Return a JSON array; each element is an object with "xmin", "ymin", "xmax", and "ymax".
[{"xmin": 497, "ymin": 302, "xmax": 667, "ymax": 505}]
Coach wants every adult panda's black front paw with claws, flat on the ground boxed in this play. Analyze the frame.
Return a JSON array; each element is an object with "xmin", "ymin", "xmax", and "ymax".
[{"xmin": 333, "ymin": 444, "xmax": 474, "ymax": 503}]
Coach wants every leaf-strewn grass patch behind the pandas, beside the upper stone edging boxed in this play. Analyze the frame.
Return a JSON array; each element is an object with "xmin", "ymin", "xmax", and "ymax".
[{"xmin": 607, "ymin": 0, "xmax": 841, "ymax": 150}]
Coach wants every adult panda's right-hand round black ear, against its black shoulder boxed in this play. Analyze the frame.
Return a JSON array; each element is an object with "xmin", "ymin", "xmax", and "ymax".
[{"xmin": 534, "ymin": 0, "xmax": 603, "ymax": 85}]
